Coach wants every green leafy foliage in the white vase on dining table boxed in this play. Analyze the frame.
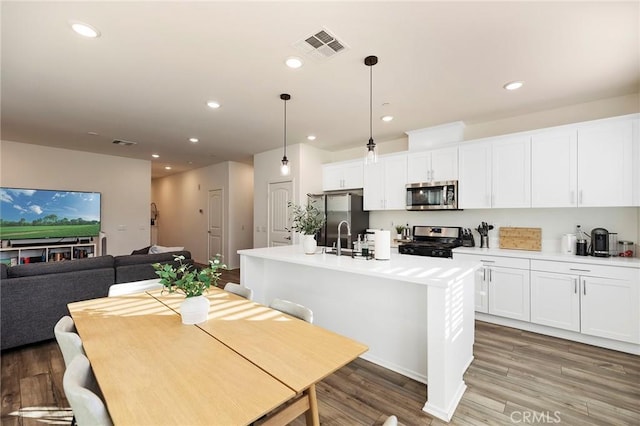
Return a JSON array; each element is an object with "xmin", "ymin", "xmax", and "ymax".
[{"xmin": 151, "ymin": 254, "xmax": 227, "ymax": 297}]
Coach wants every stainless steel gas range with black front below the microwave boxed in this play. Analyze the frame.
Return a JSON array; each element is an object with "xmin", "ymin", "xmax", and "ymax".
[{"xmin": 398, "ymin": 225, "xmax": 462, "ymax": 257}]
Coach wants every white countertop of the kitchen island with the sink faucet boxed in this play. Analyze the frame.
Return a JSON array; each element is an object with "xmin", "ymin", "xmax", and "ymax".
[{"xmin": 238, "ymin": 245, "xmax": 481, "ymax": 287}]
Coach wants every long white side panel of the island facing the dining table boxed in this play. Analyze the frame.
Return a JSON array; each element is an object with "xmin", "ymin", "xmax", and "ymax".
[{"xmin": 240, "ymin": 255, "xmax": 427, "ymax": 383}]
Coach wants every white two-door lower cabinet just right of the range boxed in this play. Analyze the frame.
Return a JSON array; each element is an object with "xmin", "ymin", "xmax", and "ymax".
[{"xmin": 454, "ymin": 254, "xmax": 530, "ymax": 321}]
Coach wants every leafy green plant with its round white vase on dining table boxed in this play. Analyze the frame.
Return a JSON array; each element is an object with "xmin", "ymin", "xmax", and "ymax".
[{"xmin": 151, "ymin": 254, "xmax": 227, "ymax": 324}]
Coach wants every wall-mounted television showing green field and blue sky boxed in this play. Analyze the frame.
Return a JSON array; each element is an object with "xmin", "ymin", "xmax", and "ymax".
[{"xmin": 0, "ymin": 187, "xmax": 100, "ymax": 240}]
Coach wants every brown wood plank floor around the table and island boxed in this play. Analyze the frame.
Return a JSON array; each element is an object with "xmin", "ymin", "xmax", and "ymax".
[{"xmin": 0, "ymin": 270, "xmax": 640, "ymax": 426}]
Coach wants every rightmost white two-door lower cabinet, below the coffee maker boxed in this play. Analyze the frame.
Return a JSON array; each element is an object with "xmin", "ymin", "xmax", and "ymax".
[{"xmin": 531, "ymin": 260, "xmax": 640, "ymax": 343}]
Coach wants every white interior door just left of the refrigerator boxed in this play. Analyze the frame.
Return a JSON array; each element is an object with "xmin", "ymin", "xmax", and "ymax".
[{"xmin": 267, "ymin": 181, "xmax": 293, "ymax": 247}]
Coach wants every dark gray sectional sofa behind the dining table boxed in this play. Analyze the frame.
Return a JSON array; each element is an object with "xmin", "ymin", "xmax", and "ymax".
[{"xmin": 0, "ymin": 251, "xmax": 193, "ymax": 350}]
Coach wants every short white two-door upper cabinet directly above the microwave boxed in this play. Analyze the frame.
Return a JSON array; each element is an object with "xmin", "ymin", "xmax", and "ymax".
[{"xmin": 407, "ymin": 147, "xmax": 458, "ymax": 183}]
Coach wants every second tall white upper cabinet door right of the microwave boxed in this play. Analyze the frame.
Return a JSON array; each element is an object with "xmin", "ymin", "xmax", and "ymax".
[{"xmin": 491, "ymin": 135, "xmax": 531, "ymax": 208}]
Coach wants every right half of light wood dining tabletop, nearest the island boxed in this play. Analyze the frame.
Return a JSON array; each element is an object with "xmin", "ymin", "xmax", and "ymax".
[{"xmin": 149, "ymin": 288, "xmax": 368, "ymax": 392}]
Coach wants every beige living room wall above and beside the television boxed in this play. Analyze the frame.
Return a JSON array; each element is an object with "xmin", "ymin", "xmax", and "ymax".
[{"xmin": 0, "ymin": 141, "xmax": 151, "ymax": 255}]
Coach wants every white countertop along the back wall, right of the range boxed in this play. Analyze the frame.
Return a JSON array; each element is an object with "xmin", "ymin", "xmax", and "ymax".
[{"xmin": 453, "ymin": 247, "xmax": 640, "ymax": 269}]
